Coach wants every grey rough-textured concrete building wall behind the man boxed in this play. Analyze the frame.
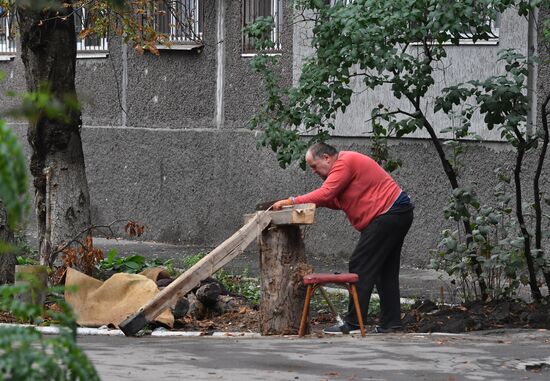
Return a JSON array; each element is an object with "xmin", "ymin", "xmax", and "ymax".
[{"xmin": 0, "ymin": 0, "xmax": 550, "ymax": 270}]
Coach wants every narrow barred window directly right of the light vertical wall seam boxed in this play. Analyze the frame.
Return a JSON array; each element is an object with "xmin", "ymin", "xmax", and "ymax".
[{"xmin": 242, "ymin": 0, "xmax": 283, "ymax": 54}]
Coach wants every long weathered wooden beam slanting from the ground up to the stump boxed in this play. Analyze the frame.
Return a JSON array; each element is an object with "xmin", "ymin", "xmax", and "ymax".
[{"xmin": 119, "ymin": 212, "xmax": 271, "ymax": 336}]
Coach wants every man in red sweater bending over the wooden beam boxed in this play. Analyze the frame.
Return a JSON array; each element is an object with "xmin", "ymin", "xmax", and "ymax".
[{"xmin": 273, "ymin": 143, "xmax": 413, "ymax": 334}]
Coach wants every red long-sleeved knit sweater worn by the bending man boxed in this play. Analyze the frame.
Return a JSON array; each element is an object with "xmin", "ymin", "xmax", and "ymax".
[{"xmin": 295, "ymin": 151, "xmax": 401, "ymax": 231}]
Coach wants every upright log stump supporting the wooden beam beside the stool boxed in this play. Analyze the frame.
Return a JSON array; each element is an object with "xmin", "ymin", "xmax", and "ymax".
[{"xmin": 260, "ymin": 225, "xmax": 311, "ymax": 335}]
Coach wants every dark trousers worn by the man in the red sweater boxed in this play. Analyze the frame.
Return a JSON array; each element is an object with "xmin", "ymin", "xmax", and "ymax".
[{"xmin": 346, "ymin": 205, "xmax": 413, "ymax": 328}]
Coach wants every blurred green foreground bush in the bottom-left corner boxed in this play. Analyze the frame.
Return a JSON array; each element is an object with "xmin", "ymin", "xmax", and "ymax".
[{"xmin": 0, "ymin": 284, "xmax": 99, "ymax": 381}]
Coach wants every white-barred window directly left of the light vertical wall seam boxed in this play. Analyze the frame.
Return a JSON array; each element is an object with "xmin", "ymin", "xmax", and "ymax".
[{"xmin": 153, "ymin": 0, "xmax": 204, "ymax": 49}]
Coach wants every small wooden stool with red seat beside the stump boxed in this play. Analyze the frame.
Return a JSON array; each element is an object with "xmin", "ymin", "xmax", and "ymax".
[{"xmin": 298, "ymin": 273, "xmax": 365, "ymax": 337}]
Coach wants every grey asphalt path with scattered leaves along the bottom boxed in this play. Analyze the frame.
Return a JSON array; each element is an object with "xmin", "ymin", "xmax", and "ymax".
[{"xmin": 82, "ymin": 330, "xmax": 550, "ymax": 381}]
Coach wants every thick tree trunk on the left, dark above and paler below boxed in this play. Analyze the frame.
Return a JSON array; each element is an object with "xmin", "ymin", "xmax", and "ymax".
[{"xmin": 17, "ymin": 0, "xmax": 90, "ymax": 266}]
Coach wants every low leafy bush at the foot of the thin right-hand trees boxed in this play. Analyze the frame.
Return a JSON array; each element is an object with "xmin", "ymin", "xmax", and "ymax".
[{"xmin": 436, "ymin": 168, "xmax": 528, "ymax": 301}]
